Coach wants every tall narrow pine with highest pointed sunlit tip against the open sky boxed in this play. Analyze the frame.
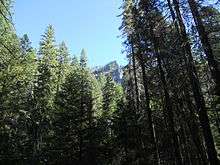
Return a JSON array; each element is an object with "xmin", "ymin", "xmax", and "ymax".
[{"xmin": 31, "ymin": 25, "xmax": 59, "ymax": 162}]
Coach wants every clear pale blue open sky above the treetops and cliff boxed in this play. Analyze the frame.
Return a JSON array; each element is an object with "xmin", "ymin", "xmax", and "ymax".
[{"xmin": 14, "ymin": 0, "xmax": 126, "ymax": 66}]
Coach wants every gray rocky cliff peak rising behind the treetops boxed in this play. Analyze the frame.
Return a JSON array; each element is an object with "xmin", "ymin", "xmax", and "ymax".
[{"xmin": 93, "ymin": 61, "xmax": 122, "ymax": 84}]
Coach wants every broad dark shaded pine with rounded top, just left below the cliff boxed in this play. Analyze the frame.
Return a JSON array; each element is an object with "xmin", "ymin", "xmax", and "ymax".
[{"xmin": 55, "ymin": 65, "xmax": 101, "ymax": 164}]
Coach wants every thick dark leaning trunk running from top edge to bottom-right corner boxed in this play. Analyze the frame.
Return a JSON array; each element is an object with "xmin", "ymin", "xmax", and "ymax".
[{"xmin": 168, "ymin": 0, "xmax": 218, "ymax": 165}]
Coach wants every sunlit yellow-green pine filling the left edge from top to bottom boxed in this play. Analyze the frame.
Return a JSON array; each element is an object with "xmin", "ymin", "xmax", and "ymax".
[{"xmin": 0, "ymin": 0, "xmax": 34, "ymax": 164}]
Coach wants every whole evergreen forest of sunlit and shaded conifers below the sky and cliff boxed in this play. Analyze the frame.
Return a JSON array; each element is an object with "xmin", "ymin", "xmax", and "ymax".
[{"xmin": 0, "ymin": 0, "xmax": 220, "ymax": 165}]
